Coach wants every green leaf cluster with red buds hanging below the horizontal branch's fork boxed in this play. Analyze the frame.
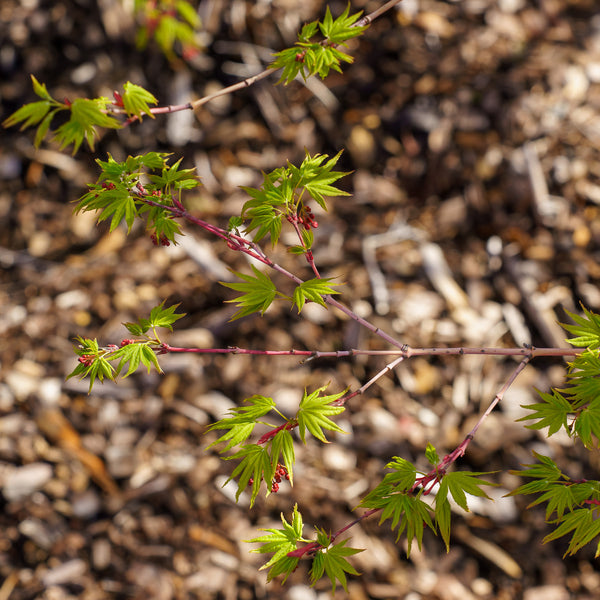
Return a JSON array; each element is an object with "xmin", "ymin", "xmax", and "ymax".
[{"xmin": 208, "ymin": 386, "xmax": 346, "ymax": 507}]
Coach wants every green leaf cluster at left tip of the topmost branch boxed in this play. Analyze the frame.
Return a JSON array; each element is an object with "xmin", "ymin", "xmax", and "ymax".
[{"xmin": 2, "ymin": 75, "xmax": 157, "ymax": 154}]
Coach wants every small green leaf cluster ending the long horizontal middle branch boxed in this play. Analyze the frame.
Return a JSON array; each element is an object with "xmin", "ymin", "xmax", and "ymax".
[{"xmin": 67, "ymin": 301, "xmax": 184, "ymax": 392}]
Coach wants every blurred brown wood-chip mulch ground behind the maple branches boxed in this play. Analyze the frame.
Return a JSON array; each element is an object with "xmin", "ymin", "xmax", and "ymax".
[{"xmin": 0, "ymin": 0, "xmax": 600, "ymax": 600}]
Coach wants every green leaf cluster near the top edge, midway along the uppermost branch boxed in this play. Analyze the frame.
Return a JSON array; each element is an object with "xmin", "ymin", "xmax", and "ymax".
[{"xmin": 270, "ymin": 4, "xmax": 367, "ymax": 84}]
